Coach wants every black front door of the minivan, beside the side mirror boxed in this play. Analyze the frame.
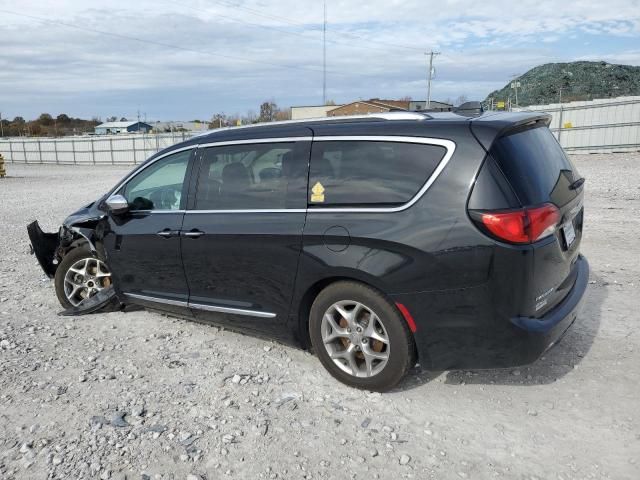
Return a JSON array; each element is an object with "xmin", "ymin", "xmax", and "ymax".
[{"xmin": 104, "ymin": 149, "xmax": 193, "ymax": 315}]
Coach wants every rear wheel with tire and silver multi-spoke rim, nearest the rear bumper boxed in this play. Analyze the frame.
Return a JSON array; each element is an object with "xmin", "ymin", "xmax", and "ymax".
[{"xmin": 309, "ymin": 281, "xmax": 416, "ymax": 392}]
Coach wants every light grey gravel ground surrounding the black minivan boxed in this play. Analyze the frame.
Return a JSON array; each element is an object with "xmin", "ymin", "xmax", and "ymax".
[{"xmin": 0, "ymin": 154, "xmax": 640, "ymax": 480}]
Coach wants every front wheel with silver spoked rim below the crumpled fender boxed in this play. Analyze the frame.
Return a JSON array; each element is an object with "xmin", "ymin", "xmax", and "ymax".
[{"xmin": 55, "ymin": 248, "xmax": 111, "ymax": 309}]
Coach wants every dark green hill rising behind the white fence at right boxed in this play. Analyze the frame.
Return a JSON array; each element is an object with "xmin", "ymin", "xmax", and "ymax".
[{"xmin": 485, "ymin": 62, "xmax": 640, "ymax": 106}]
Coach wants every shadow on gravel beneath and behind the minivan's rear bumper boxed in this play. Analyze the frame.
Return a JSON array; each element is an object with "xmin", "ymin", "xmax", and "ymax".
[{"xmin": 395, "ymin": 273, "xmax": 607, "ymax": 391}]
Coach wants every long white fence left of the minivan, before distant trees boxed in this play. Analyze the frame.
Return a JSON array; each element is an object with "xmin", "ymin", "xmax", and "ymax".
[{"xmin": 0, "ymin": 132, "xmax": 193, "ymax": 165}]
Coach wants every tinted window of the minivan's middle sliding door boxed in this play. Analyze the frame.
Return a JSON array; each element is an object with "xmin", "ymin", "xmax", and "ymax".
[{"xmin": 195, "ymin": 143, "xmax": 308, "ymax": 210}]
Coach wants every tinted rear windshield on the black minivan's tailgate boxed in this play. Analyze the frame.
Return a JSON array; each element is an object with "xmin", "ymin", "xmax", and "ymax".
[{"xmin": 491, "ymin": 127, "xmax": 580, "ymax": 207}]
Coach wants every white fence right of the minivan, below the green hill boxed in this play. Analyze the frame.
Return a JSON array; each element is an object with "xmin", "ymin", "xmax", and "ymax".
[{"xmin": 514, "ymin": 96, "xmax": 640, "ymax": 153}]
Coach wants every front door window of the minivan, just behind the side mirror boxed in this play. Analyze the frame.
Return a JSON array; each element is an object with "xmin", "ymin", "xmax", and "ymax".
[{"xmin": 122, "ymin": 150, "xmax": 191, "ymax": 210}]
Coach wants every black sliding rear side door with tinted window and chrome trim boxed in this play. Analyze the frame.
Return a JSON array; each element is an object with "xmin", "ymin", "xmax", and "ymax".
[{"xmin": 182, "ymin": 138, "xmax": 311, "ymax": 339}]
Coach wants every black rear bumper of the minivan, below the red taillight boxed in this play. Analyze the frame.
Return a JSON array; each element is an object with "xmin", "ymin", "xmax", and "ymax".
[{"xmin": 394, "ymin": 255, "xmax": 589, "ymax": 370}]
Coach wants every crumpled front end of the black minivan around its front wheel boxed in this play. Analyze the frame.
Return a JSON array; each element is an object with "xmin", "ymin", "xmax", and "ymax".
[{"xmin": 27, "ymin": 203, "xmax": 120, "ymax": 315}]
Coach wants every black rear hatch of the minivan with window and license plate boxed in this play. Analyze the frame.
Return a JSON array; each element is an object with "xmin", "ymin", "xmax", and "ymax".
[{"xmin": 489, "ymin": 122, "xmax": 584, "ymax": 317}]
